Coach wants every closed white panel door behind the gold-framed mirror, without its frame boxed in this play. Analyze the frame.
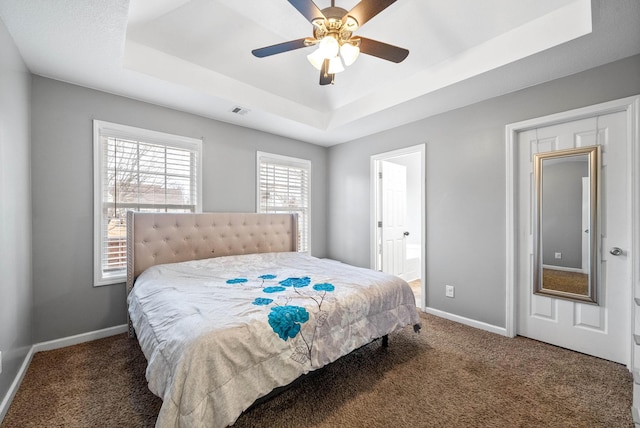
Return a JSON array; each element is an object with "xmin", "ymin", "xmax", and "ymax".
[{"xmin": 517, "ymin": 112, "xmax": 631, "ymax": 364}]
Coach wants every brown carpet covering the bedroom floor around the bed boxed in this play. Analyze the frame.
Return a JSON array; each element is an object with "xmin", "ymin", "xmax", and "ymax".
[{"xmin": 1, "ymin": 315, "xmax": 633, "ymax": 428}]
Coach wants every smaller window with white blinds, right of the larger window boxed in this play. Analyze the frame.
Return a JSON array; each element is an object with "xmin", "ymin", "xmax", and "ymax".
[{"xmin": 257, "ymin": 152, "xmax": 311, "ymax": 252}]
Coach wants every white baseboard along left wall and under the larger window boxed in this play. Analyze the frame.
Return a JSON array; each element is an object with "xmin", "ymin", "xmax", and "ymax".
[{"xmin": 0, "ymin": 324, "xmax": 128, "ymax": 422}]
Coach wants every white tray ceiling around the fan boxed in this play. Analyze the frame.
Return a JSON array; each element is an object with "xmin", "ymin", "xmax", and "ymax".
[{"xmin": 0, "ymin": 0, "xmax": 640, "ymax": 146}]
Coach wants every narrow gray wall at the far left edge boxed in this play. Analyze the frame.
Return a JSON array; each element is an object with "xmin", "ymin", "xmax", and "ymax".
[{"xmin": 0, "ymin": 21, "xmax": 33, "ymax": 408}]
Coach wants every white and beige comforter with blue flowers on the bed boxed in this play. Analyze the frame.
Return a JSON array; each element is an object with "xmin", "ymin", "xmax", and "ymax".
[{"xmin": 128, "ymin": 253, "xmax": 420, "ymax": 427}]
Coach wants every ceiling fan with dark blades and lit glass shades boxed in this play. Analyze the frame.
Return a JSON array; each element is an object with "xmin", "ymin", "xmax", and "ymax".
[{"xmin": 251, "ymin": 0, "xmax": 409, "ymax": 85}]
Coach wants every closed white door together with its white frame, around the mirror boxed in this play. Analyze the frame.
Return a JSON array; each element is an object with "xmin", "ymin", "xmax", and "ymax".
[{"xmin": 506, "ymin": 94, "xmax": 638, "ymax": 368}]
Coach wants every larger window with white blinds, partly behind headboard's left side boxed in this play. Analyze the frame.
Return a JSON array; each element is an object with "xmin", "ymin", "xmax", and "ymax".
[{"xmin": 93, "ymin": 120, "xmax": 202, "ymax": 286}]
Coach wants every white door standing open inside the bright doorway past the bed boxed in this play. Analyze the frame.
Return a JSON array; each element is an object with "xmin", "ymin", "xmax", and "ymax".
[{"xmin": 381, "ymin": 161, "xmax": 407, "ymax": 279}]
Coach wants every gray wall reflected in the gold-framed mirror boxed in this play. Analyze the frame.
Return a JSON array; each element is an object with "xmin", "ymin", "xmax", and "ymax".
[{"xmin": 542, "ymin": 161, "xmax": 589, "ymax": 269}]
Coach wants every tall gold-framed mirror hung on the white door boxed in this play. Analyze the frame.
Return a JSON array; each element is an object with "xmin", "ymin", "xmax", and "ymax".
[{"xmin": 533, "ymin": 146, "xmax": 600, "ymax": 304}]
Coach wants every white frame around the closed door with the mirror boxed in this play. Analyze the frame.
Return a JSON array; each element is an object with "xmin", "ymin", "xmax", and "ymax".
[{"xmin": 505, "ymin": 95, "xmax": 640, "ymax": 366}]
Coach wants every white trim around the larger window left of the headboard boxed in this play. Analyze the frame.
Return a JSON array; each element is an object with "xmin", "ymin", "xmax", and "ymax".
[{"xmin": 93, "ymin": 120, "xmax": 202, "ymax": 287}]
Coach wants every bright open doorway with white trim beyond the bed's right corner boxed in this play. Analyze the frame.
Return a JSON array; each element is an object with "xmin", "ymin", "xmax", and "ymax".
[{"xmin": 371, "ymin": 144, "xmax": 426, "ymax": 310}]
